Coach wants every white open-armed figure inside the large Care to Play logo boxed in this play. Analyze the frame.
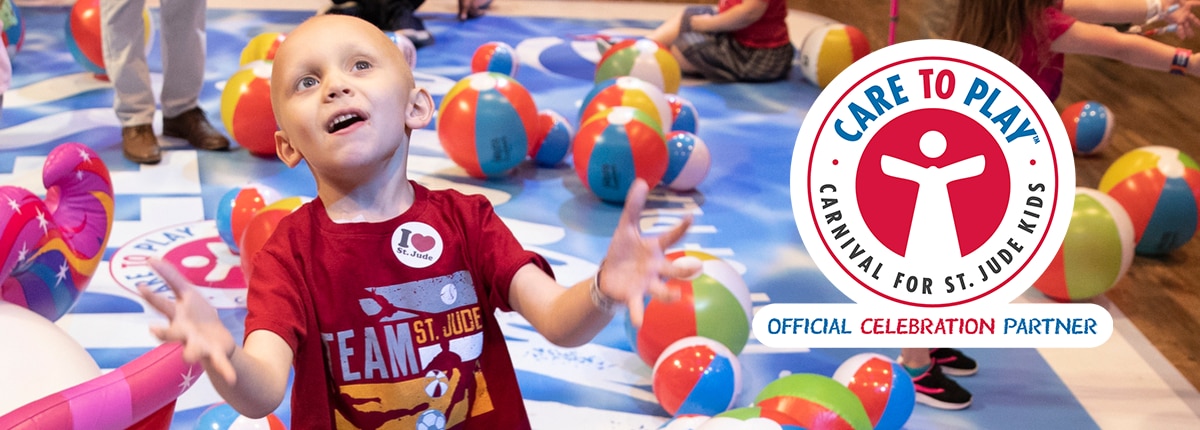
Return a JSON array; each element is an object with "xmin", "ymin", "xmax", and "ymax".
[{"xmin": 880, "ymin": 131, "xmax": 985, "ymax": 258}]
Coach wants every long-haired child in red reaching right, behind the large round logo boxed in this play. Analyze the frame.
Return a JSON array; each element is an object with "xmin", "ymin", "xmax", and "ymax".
[{"xmin": 948, "ymin": 0, "xmax": 1200, "ymax": 101}]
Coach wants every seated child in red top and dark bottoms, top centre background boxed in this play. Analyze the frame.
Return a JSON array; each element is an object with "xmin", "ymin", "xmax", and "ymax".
[{"xmin": 647, "ymin": 0, "xmax": 796, "ymax": 82}]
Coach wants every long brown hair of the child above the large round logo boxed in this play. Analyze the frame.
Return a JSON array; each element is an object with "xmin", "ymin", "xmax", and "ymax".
[{"xmin": 949, "ymin": 0, "xmax": 1061, "ymax": 65}]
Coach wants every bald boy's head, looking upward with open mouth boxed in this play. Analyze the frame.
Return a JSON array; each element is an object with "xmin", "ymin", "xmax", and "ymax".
[{"xmin": 271, "ymin": 16, "xmax": 433, "ymax": 175}]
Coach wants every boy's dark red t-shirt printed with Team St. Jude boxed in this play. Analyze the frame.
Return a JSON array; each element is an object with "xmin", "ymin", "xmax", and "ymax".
[{"xmin": 246, "ymin": 183, "xmax": 553, "ymax": 429}]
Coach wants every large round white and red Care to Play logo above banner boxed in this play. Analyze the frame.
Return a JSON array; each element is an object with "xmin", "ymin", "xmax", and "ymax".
[{"xmin": 792, "ymin": 40, "xmax": 1075, "ymax": 306}]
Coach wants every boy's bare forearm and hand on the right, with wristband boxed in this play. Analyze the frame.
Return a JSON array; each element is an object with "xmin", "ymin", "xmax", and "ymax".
[{"xmin": 509, "ymin": 179, "xmax": 700, "ymax": 347}]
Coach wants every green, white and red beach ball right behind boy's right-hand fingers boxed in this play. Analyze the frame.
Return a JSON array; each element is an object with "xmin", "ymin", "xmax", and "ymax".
[{"xmin": 625, "ymin": 250, "xmax": 751, "ymax": 366}]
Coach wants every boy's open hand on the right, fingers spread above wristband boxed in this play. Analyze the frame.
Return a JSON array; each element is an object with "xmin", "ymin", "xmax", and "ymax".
[{"xmin": 598, "ymin": 179, "xmax": 700, "ymax": 327}]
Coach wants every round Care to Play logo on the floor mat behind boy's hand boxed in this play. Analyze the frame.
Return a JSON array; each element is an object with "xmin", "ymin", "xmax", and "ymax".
[{"xmin": 109, "ymin": 221, "xmax": 246, "ymax": 309}]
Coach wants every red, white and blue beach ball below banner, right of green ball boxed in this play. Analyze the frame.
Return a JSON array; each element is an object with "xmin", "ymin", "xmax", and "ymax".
[{"xmin": 833, "ymin": 352, "xmax": 917, "ymax": 430}]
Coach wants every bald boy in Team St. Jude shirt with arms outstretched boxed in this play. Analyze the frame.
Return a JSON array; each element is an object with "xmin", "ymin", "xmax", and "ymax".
[{"xmin": 142, "ymin": 14, "xmax": 698, "ymax": 429}]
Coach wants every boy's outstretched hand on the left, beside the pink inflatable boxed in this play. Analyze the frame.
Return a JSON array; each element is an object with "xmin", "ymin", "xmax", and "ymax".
[{"xmin": 138, "ymin": 259, "xmax": 236, "ymax": 386}]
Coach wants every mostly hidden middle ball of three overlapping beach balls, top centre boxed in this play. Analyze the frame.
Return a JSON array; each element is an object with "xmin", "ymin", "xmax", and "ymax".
[{"xmin": 580, "ymin": 76, "xmax": 671, "ymax": 133}]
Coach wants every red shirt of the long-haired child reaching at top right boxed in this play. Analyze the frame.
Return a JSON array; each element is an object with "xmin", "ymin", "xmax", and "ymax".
[{"xmin": 1019, "ymin": 4, "xmax": 1075, "ymax": 101}]
